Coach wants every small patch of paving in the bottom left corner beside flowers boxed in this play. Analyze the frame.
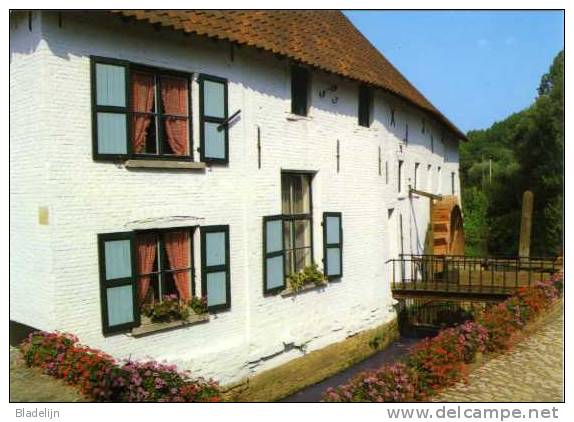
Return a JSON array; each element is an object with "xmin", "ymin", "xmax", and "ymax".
[{"xmin": 10, "ymin": 346, "xmax": 87, "ymax": 402}]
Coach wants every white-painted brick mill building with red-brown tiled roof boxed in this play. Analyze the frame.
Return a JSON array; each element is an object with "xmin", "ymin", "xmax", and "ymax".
[{"xmin": 10, "ymin": 12, "xmax": 464, "ymax": 383}]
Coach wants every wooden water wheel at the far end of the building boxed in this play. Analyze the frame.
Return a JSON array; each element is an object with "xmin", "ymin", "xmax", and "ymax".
[{"xmin": 430, "ymin": 195, "xmax": 464, "ymax": 255}]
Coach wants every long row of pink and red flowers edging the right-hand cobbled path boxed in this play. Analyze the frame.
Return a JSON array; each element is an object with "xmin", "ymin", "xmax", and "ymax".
[{"xmin": 323, "ymin": 273, "xmax": 563, "ymax": 402}]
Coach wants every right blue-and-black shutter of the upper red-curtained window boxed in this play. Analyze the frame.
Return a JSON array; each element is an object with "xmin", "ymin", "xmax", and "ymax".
[{"xmin": 199, "ymin": 75, "xmax": 229, "ymax": 163}]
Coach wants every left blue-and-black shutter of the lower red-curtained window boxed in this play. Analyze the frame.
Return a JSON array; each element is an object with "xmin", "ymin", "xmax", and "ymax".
[{"xmin": 98, "ymin": 232, "xmax": 140, "ymax": 335}]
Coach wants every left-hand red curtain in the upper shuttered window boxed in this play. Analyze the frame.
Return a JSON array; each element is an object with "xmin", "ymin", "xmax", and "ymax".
[{"xmin": 131, "ymin": 72, "xmax": 154, "ymax": 153}]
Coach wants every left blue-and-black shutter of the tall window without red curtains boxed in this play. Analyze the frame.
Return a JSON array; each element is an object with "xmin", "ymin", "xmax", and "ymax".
[{"xmin": 263, "ymin": 215, "xmax": 285, "ymax": 294}]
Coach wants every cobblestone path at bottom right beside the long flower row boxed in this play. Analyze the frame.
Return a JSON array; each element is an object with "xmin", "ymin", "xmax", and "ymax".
[{"xmin": 433, "ymin": 306, "xmax": 564, "ymax": 402}]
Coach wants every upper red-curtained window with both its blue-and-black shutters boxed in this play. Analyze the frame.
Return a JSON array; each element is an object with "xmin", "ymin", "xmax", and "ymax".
[{"xmin": 92, "ymin": 57, "xmax": 228, "ymax": 162}]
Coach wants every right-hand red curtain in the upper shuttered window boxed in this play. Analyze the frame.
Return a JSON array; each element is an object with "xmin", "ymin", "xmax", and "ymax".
[{"xmin": 161, "ymin": 77, "xmax": 189, "ymax": 155}]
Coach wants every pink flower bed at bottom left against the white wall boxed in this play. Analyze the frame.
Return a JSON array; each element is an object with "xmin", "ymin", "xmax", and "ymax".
[{"xmin": 20, "ymin": 331, "xmax": 221, "ymax": 402}]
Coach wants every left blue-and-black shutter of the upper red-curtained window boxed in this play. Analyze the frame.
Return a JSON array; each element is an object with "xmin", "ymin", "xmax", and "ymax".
[{"xmin": 91, "ymin": 57, "xmax": 131, "ymax": 160}]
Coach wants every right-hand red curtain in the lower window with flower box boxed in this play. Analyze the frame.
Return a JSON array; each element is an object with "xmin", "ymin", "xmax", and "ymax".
[{"xmin": 164, "ymin": 231, "xmax": 191, "ymax": 301}]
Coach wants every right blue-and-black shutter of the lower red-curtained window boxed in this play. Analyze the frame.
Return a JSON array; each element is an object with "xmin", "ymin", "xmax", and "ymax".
[{"xmin": 201, "ymin": 226, "xmax": 231, "ymax": 311}]
